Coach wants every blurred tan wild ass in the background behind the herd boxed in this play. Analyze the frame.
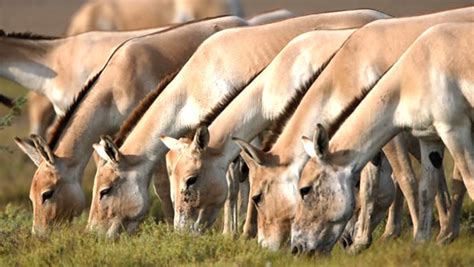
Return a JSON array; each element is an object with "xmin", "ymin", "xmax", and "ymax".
[{"xmin": 66, "ymin": 0, "xmax": 242, "ymax": 35}]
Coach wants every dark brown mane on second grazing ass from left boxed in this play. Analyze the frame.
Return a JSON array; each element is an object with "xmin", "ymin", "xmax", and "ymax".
[{"xmin": 114, "ymin": 69, "xmax": 179, "ymax": 147}]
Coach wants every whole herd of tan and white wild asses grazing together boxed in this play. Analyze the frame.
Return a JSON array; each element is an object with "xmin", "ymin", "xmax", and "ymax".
[{"xmin": 0, "ymin": 0, "xmax": 474, "ymax": 254}]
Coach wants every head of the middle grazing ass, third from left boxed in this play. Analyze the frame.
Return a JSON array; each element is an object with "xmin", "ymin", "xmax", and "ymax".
[{"xmin": 161, "ymin": 126, "xmax": 227, "ymax": 232}]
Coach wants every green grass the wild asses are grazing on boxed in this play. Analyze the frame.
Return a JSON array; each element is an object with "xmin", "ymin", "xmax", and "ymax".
[{"xmin": 0, "ymin": 78, "xmax": 474, "ymax": 267}]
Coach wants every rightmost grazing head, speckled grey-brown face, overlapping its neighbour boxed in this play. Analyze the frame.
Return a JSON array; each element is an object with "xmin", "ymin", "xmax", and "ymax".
[{"xmin": 291, "ymin": 124, "xmax": 355, "ymax": 254}]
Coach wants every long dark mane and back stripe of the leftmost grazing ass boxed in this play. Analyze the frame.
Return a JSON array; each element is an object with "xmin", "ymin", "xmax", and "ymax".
[{"xmin": 48, "ymin": 16, "xmax": 233, "ymax": 149}]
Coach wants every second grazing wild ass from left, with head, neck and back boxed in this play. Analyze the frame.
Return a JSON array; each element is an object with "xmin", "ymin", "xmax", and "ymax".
[{"xmin": 89, "ymin": 10, "xmax": 388, "ymax": 238}]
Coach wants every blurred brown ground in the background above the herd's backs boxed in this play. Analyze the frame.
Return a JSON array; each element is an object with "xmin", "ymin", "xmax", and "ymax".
[{"xmin": 0, "ymin": 0, "xmax": 474, "ymax": 35}]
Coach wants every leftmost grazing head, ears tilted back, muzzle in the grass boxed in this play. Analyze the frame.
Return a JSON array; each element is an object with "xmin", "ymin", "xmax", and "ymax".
[{"xmin": 15, "ymin": 135, "xmax": 85, "ymax": 234}]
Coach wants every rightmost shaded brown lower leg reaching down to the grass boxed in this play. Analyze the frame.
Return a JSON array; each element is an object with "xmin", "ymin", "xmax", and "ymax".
[{"xmin": 437, "ymin": 166, "xmax": 466, "ymax": 244}]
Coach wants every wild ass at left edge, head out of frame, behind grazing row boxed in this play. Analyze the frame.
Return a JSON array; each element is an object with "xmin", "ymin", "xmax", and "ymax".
[{"xmin": 0, "ymin": 28, "xmax": 161, "ymax": 136}]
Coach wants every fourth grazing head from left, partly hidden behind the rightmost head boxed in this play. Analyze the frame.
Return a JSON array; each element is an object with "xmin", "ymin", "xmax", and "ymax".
[{"xmin": 235, "ymin": 139, "xmax": 298, "ymax": 250}]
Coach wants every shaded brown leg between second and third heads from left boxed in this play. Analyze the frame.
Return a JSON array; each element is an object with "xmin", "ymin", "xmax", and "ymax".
[{"xmin": 153, "ymin": 158, "xmax": 174, "ymax": 224}]
